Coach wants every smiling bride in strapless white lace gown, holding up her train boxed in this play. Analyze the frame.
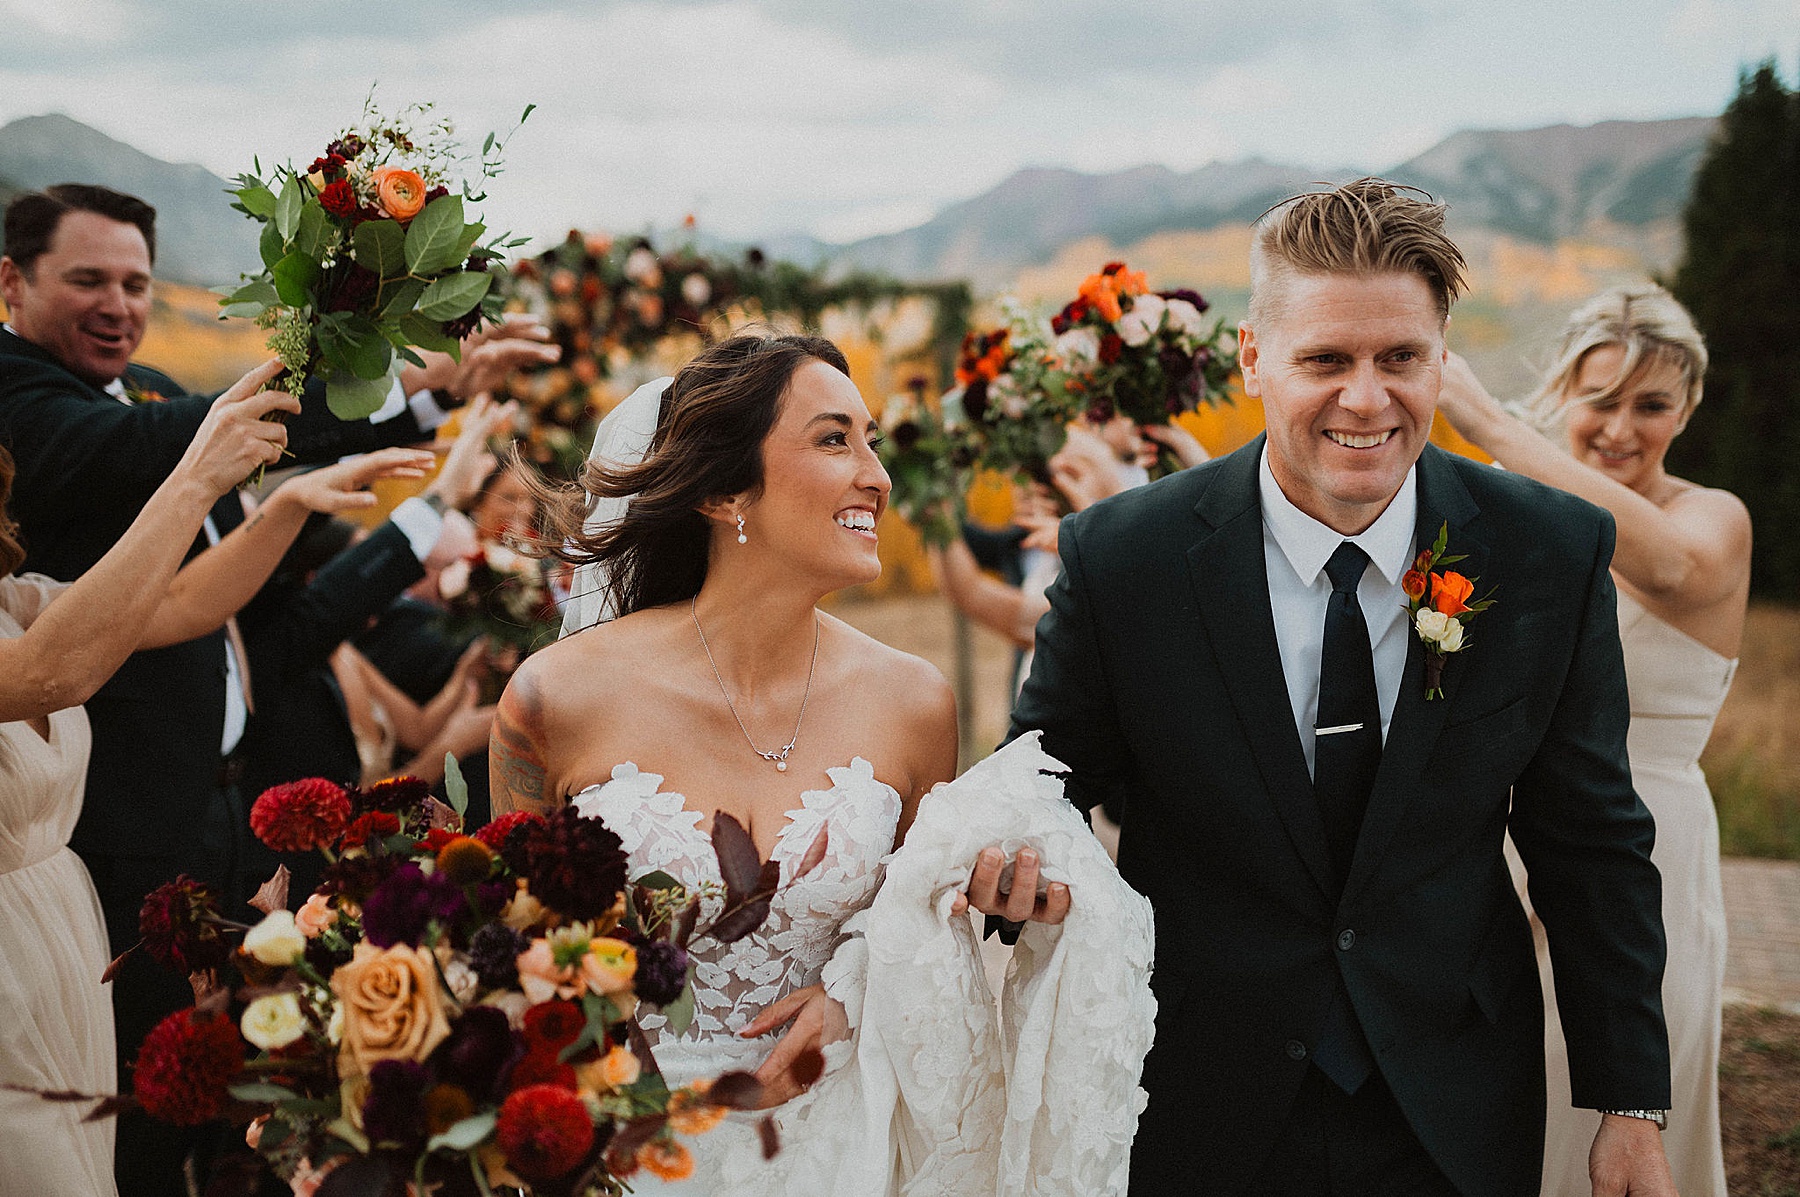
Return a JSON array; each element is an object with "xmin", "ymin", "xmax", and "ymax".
[{"xmin": 491, "ymin": 335, "xmax": 1150, "ymax": 1193}]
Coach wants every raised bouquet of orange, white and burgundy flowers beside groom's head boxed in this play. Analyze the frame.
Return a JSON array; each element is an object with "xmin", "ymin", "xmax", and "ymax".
[{"xmin": 1049, "ymin": 261, "xmax": 1237, "ymax": 471}]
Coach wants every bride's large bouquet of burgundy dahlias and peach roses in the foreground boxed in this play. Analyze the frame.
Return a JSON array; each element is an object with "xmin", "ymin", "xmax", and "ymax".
[{"xmin": 105, "ymin": 761, "xmax": 824, "ymax": 1197}]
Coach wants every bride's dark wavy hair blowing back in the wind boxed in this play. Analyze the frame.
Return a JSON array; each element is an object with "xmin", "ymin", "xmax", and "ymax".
[{"xmin": 532, "ymin": 333, "xmax": 850, "ymax": 616}]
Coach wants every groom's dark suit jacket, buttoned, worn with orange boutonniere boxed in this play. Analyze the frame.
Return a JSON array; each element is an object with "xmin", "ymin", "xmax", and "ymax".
[{"xmin": 1013, "ymin": 439, "xmax": 1669, "ymax": 1195}]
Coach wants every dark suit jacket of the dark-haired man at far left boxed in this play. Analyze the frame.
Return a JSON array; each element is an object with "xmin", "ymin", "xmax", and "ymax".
[{"xmin": 0, "ymin": 329, "xmax": 428, "ymax": 857}]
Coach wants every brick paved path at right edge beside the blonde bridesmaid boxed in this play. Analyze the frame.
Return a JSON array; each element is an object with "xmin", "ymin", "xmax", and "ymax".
[{"xmin": 1724, "ymin": 857, "xmax": 1800, "ymax": 1013}]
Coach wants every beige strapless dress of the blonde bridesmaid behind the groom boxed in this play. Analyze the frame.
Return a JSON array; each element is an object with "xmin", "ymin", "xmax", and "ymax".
[{"xmin": 1534, "ymin": 590, "xmax": 1737, "ymax": 1197}]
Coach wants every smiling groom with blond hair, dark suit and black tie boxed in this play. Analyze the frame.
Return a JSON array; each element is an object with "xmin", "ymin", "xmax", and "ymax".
[{"xmin": 1013, "ymin": 180, "xmax": 1674, "ymax": 1197}]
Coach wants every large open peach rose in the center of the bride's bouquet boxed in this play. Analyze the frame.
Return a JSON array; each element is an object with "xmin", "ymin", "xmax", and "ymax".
[{"xmin": 331, "ymin": 941, "xmax": 450, "ymax": 1076}]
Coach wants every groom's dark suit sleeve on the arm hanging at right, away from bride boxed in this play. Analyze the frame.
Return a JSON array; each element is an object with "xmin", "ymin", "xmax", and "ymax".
[{"xmin": 1510, "ymin": 515, "xmax": 1670, "ymax": 1109}]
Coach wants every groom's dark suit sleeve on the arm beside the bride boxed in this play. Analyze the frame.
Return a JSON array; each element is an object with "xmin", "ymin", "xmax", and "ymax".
[{"xmin": 1006, "ymin": 515, "xmax": 1132, "ymax": 810}]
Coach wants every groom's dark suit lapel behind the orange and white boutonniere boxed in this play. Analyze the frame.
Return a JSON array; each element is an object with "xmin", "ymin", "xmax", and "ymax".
[{"xmin": 1343, "ymin": 445, "xmax": 1487, "ymax": 902}]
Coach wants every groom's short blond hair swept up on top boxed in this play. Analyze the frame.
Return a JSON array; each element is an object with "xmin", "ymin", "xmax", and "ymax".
[{"xmin": 1247, "ymin": 178, "xmax": 1467, "ymax": 328}]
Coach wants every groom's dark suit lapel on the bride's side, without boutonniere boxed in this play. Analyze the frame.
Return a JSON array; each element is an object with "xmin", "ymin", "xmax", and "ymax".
[{"xmin": 1188, "ymin": 437, "xmax": 1339, "ymax": 895}]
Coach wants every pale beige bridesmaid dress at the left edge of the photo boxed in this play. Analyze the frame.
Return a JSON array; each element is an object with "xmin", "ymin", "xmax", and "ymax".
[{"xmin": 0, "ymin": 574, "xmax": 119, "ymax": 1197}]
